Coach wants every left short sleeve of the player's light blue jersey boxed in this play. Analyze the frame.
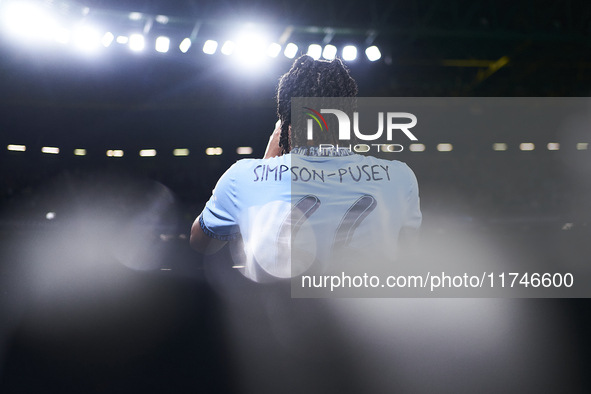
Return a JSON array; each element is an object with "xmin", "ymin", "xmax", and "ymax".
[{"xmin": 199, "ymin": 164, "xmax": 240, "ymax": 241}]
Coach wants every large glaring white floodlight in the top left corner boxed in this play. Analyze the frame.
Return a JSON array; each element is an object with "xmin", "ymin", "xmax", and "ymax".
[{"xmin": 0, "ymin": 2, "xmax": 57, "ymax": 39}]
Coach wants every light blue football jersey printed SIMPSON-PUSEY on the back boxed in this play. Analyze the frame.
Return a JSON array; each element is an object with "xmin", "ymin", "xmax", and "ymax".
[{"xmin": 200, "ymin": 148, "xmax": 422, "ymax": 280}]
